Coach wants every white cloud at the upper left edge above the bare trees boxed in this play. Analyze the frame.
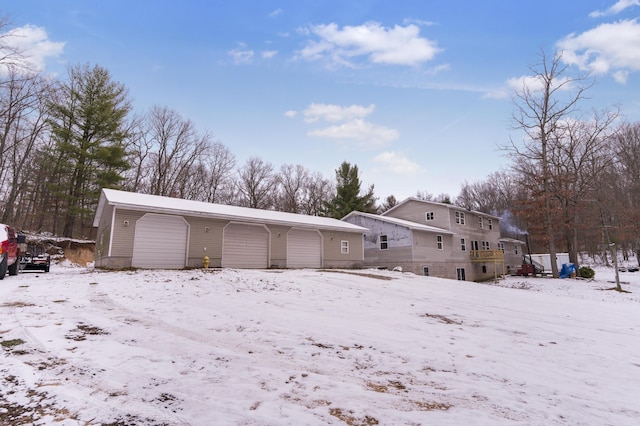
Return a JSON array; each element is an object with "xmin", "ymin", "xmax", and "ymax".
[{"xmin": 0, "ymin": 25, "xmax": 65, "ymax": 71}]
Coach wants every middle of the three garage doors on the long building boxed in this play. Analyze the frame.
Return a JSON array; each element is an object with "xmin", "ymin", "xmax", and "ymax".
[{"xmin": 222, "ymin": 223, "xmax": 269, "ymax": 268}]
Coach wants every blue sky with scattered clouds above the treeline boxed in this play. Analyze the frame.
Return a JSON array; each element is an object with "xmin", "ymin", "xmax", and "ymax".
[{"xmin": 0, "ymin": 0, "xmax": 640, "ymax": 201}]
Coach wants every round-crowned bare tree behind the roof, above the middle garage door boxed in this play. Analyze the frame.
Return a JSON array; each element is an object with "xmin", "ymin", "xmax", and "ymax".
[{"xmin": 237, "ymin": 157, "xmax": 277, "ymax": 209}]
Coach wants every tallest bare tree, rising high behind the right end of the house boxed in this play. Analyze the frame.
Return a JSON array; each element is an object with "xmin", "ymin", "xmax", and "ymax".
[{"xmin": 506, "ymin": 51, "xmax": 588, "ymax": 278}]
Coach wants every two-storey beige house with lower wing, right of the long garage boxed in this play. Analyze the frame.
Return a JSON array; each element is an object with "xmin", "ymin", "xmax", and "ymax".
[{"xmin": 343, "ymin": 198, "xmax": 505, "ymax": 281}]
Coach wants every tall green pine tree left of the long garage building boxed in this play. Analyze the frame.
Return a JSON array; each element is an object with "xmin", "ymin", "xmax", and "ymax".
[{"xmin": 51, "ymin": 65, "xmax": 131, "ymax": 237}]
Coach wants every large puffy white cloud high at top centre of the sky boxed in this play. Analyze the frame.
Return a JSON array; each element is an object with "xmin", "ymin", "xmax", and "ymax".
[{"xmin": 299, "ymin": 22, "xmax": 441, "ymax": 67}]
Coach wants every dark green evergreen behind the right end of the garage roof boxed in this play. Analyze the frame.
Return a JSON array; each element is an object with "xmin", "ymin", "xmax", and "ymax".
[{"xmin": 324, "ymin": 161, "xmax": 376, "ymax": 219}]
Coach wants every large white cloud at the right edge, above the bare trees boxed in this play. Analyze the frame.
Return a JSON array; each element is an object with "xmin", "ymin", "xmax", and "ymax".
[{"xmin": 558, "ymin": 19, "xmax": 640, "ymax": 81}]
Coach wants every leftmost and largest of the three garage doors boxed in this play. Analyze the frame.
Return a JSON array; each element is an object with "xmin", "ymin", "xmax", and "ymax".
[{"xmin": 131, "ymin": 213, "xmax": 189, "ymax": 269}]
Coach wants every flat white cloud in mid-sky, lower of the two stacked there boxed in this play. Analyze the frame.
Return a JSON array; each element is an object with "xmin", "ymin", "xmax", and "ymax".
[{"xmin": 308, "ymin": 119, "xmax": 399, "ymax": 148}]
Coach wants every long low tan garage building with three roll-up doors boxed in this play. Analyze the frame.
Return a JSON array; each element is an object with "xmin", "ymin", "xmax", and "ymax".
[{"xmin": 93, "ymin": 189, "xmax": 366, "ymax": 269}]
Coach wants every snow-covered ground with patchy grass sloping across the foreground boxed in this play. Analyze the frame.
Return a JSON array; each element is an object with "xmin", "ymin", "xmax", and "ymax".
[{"xmin": 0, "ymin": 265, "xmax": 640, "ymax": 425}]
